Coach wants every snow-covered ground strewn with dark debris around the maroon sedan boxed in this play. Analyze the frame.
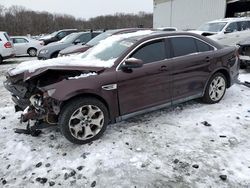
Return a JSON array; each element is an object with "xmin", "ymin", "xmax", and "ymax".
[{"xmin": 0, "ymin": 59, "xmax": 250, "ymax": 188}]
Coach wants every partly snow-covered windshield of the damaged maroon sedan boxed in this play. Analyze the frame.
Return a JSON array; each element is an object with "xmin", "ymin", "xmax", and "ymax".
[{"xmin": 81, "ymin": 37, "xmax": 134, "ymax": 61}]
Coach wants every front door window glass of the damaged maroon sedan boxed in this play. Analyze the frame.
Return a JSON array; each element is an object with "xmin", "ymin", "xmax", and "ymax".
[{"xmin": 130, "ymin": 40, "xmax": 167, "ymax": 63}]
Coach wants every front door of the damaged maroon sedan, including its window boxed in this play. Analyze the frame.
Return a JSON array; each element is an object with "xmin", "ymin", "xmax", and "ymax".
[{"xmin": 117, "ymin": 39, "xmax": 171, "ymax": 115}]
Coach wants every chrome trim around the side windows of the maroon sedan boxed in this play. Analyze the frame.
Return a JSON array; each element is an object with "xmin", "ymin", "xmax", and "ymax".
[{"xmin": 115, "ymin": 35, "xmax": 218, "ymax": 72}]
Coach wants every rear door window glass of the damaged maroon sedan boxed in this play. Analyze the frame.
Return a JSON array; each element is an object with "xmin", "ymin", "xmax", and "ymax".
[{"xmin": 170, "ymin": 37, "xmax": 197, "ymax": 57}]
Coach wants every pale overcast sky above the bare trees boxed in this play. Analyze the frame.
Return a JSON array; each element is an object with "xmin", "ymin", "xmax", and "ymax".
[{"xmin": 0, "ymin": 0, "xmax": 153, "ymax": 19}]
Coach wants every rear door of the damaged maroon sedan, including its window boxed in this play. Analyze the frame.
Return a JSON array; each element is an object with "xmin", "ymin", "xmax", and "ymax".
[{"xmin": 169, "ymin": 36, "xmax": 215, "ymax": 101}]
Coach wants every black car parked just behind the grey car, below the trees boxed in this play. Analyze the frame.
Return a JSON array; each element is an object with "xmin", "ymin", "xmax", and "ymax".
[{"xmin": 39, "ymin": 29, "xmax": 77, "ymax": 45}]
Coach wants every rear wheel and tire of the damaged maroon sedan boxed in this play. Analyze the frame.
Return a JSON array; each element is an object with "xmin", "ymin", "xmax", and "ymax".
[{"xmin": 202, "ymin": 73, "xmax": 227, "ymax": 104}]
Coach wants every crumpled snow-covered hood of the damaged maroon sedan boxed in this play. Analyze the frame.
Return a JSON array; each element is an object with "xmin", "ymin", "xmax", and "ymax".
[{"xmin": 8, "ymin": 55, "xmax": 115, "ymax": 81}]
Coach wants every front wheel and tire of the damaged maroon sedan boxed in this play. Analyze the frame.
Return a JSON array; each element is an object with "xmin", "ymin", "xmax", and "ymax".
[{"xmin": 58, "ymin": 97, "xmax": 109, "ymax": 144}]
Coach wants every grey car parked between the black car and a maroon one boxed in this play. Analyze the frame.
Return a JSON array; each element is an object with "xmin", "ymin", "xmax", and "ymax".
[{"xmin": 37, "ymin": 32, "xmax": 101, "ymax": 60}]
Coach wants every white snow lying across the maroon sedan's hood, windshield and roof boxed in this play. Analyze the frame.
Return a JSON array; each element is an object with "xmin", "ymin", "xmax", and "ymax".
[{"xmin": 10, "ymin": 30, "xmax": 153, "ymax": 75}]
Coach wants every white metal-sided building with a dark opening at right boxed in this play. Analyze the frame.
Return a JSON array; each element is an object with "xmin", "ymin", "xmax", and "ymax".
[{"xmin": 154, "ymin": 0, "xmax": 250, "ymax": 30}]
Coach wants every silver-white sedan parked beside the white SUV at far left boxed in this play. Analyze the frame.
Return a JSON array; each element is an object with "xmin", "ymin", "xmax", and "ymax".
[{"xmin": 10, "ymin": 36, "xmax": 43, "ymax": 57}]
